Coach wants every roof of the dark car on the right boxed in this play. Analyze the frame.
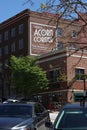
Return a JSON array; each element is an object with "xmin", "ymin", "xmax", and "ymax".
[{"xmin": 64, "ymin": 102, "xmax": 87, "ymax": 108}]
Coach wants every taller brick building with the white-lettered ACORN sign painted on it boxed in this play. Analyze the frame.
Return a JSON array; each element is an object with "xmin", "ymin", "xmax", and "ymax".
[{"xmin": 0, "ymin": 9, "xmax": 85, "ymax": 103}]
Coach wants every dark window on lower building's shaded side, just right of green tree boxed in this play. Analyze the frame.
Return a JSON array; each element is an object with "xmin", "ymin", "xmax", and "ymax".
[{"xmin": 50, "ymin": 69, "xmax": 60, "ymax": 82}]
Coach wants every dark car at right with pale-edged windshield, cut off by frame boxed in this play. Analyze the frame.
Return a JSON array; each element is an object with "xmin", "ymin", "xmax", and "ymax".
[{"xmin": 46, "ymin": 103, "xmax": 87, "ymax": 130}]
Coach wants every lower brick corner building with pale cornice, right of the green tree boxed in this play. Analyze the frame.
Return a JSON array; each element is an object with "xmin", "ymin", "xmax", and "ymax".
[{"xmin": 38, "ymin": 48, "xmax": 87, "ymax": 104}]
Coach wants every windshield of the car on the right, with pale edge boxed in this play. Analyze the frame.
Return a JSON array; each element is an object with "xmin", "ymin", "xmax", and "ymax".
[{"xmin": 55, "ymin": 108, "xmax": 87, "ymax": 130}]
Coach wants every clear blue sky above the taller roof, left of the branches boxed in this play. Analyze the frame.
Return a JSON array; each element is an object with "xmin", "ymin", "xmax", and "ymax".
[{"xmin": 0, "ymin": 0, "xmax": 45, "ymax": 23}]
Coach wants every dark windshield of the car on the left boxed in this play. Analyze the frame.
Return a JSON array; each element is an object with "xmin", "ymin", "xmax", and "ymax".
[{"xmin": 0, "ymin": 105, "xmax": 32, "ymax": 117}]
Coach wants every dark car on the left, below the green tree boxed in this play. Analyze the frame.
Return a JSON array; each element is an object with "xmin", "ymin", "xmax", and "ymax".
[{"xmin": 0, "ymin": 102, "xmax": 49, "ymax": 130}]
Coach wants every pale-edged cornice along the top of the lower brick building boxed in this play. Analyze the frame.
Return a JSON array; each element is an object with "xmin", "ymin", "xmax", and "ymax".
[{"xmin": 38, "ymin": 48, "xmax": 87, "ymax": 63}]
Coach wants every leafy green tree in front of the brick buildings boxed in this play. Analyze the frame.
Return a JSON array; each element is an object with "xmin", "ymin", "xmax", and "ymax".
[{"xmin": 11, "ymin": 56, "xmax": 48, "ymax": 96}]
